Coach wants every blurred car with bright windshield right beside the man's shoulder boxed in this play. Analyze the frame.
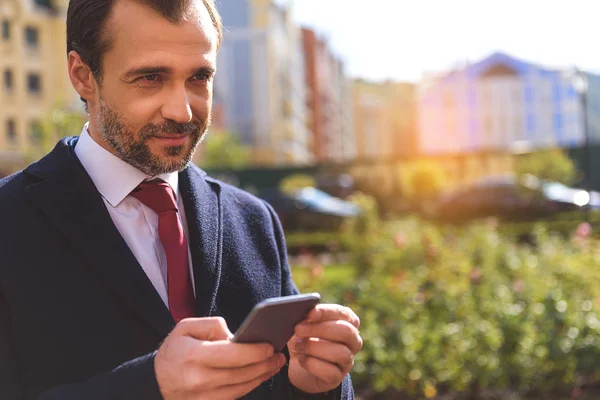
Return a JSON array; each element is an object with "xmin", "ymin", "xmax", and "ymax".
[{"xmin": 259, "ymin": 187, "xmax": 361, "ymax": 231}]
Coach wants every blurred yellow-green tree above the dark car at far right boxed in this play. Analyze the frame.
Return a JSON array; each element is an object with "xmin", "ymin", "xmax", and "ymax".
[{"xmin": 516, "ymin": 149, "xmax": 578, "ymax": 185}]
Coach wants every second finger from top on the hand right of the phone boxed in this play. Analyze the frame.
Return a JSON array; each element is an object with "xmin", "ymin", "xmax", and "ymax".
[{"xmin": 294, "ymin": 320, "xmax": 363, "ymax": 354}]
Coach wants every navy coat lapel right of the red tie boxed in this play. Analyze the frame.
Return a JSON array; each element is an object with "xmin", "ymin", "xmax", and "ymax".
[{"xmin": 179, "ymin": 166, "xmax": 223, "ymax": 317}]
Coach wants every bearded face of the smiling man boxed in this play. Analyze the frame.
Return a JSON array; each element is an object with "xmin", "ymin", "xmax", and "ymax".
[{"xmin": 88, "ymin": 0, "xmax": 217, "ymax": 176}]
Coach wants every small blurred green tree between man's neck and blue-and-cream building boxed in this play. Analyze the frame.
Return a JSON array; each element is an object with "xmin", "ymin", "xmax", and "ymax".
[{"xmin": 196, "ymin": 132, "xmax": 251, "ymax": 168}]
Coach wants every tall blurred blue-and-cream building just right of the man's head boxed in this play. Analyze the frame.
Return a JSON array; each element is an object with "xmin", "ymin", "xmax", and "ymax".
[{"xmin": 215, "ymin": 0, "xmax": 312, "ymax": 165}]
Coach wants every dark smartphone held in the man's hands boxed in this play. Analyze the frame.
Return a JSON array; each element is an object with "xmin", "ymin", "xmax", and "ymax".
[{"xmin": 233, "ymin": 293, "xmax": 321, "ymax": 351}]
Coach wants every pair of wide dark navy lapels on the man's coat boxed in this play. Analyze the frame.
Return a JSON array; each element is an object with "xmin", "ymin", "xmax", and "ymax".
[{"xmin": 25, "ymin": 137, "xmax": 222, "ymax": 336}]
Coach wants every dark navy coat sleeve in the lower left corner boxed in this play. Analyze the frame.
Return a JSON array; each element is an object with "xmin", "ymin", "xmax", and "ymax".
[{"xmin": 0, "ymin": 292, "xmax": 162, "ymax": 400}]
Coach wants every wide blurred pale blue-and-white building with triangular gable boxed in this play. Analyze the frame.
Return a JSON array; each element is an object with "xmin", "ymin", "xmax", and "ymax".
[{"xmin": 418, "ymin": 53, "xmax": 600, "ymax": 155}]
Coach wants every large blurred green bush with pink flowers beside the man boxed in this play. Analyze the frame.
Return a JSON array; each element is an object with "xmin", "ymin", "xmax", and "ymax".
[{"xmin": 300, "ymin": 211, "xmax": 600, "ymax": 399}]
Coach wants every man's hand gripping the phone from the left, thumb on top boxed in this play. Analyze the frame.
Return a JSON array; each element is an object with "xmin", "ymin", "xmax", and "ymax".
[{"xmin": 154, "ymin": 318, "xmax": 286, "ymax": 400}]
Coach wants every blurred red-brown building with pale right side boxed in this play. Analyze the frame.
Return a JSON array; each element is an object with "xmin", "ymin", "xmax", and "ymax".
[{"xmin": 302, "ymin": 28, "xmax": 356, "ymax": 162}]
